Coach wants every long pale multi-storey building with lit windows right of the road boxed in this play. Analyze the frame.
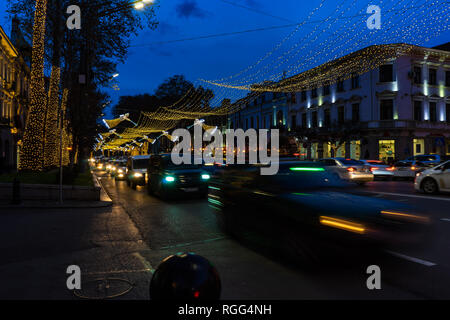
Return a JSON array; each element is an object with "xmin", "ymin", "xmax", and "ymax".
[{"xmin": 230, "ymin": 47, "xmax": 450, "ymax": 161}]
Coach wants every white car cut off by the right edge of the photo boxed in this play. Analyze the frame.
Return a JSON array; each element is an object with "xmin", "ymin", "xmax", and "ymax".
[{"xmin": 414, "ymin": 160, "xmax": 450, "ymax": 194}]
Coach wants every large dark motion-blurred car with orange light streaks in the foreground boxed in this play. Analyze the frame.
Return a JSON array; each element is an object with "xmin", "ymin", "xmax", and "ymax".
[{"xmin": 208, "ymin": 162, "xmax": 429, "ymax": 266}]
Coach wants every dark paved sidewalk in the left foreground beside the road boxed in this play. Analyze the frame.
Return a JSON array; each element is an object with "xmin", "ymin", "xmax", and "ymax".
[{"xmin": 0, "ymin": 195, "xmax": 153, "ymax": 299}]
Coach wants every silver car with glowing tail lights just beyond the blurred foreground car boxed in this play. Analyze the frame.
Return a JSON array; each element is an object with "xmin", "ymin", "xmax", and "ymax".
[{"xmin": 318, "ymin": 158, "xmax": 374, "ymax": 184}]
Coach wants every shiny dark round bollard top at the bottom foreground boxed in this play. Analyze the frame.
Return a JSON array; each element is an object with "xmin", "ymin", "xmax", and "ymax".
[{"xmin": 150, "ymin": 253, "xmax": 221, "ymax": 301}]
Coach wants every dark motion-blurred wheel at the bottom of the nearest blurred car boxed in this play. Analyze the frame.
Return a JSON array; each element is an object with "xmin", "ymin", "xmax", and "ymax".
[{"xmin": 283, "ymin": 229, "xmax": 320, "ymax": 270}]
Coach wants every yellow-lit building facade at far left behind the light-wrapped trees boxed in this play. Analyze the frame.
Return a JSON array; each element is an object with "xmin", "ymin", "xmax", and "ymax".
[{"xmin": 0, "ymin": 27, "xmax": 30, "ymax": 172}]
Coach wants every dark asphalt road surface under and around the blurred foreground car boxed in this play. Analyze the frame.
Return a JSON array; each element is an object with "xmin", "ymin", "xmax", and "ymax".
[{"xmin": 93, "ymin": 173, "xmax": 450, "ymax": 299}]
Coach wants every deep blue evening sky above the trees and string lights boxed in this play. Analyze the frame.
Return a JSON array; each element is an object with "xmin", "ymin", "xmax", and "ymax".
[{"xmin": 0, "ymin": 0, "xmax": 450, "ymax": 118}]
